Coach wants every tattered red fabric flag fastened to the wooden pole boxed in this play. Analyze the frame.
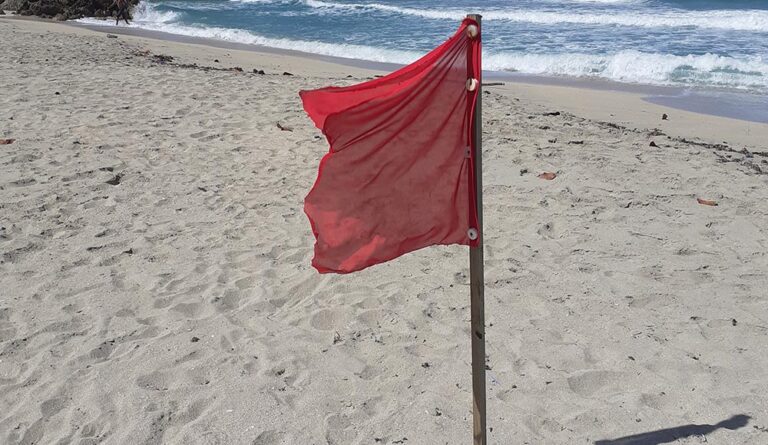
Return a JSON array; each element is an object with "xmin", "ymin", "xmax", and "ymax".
[{"xmin": 300, "ymin": 19, "xmax": 480, "ymax": 273}]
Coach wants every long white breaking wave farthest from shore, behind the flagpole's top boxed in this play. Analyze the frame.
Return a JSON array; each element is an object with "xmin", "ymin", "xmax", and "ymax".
[{"xmin": 304, "ymin": 0, "xmax": 768, "ymax": 32}]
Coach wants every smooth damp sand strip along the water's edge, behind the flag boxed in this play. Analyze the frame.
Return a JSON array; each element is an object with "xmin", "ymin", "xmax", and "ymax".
[{"xmin": 0, "ymin": 16, "xmax": 768, "ymax": 148}]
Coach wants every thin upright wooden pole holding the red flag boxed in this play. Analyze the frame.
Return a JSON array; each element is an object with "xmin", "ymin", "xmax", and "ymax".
[{"xmin": 467, "ymin": 14, "xmax": 487, "ymax": 445}]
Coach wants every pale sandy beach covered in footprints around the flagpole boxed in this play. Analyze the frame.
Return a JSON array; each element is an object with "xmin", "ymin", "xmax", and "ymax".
[{"xmin": 0, "ymin": 17, "xmax": 768, "ymax": 445}]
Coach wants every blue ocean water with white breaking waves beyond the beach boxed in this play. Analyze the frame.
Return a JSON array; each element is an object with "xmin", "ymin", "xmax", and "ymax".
[{"xmin": 76, "ymin": 0, "xmax": 768, "ymax": 95}]
